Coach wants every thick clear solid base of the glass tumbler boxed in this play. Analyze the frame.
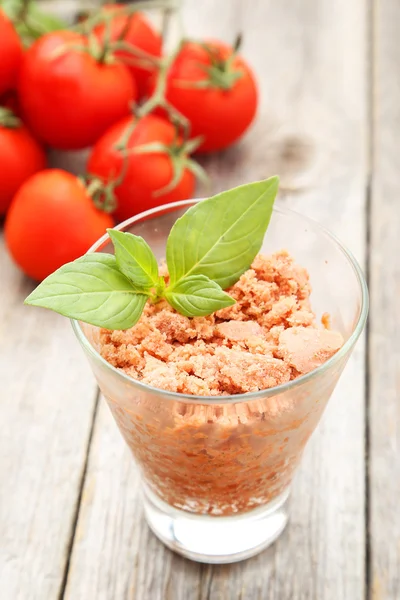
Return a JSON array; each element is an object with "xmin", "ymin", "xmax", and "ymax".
[{"xmin": 143, "ymin": 485, "xmax": 289, "ymax": 564}]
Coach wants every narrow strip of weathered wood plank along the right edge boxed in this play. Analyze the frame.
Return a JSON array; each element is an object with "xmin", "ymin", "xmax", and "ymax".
[{"xmin": 369, "ymin": 1, "xmax": 400, "ymax": 600}]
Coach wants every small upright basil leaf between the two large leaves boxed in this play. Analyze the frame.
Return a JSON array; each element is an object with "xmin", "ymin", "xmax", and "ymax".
[{"xmin": 107, "ymin": 229, "xmax": 158, "ymax": 289}]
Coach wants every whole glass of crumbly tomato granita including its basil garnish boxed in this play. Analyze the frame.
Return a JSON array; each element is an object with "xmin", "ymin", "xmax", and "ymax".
[{"xmin": 25, "ymin": 176, "xmax": 368, "ymax": 563}]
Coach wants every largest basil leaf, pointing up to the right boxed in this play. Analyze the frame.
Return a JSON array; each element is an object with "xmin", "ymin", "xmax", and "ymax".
[{"xmin": 166, "ymin": 177, "xmax": 279, "ymax": 289}]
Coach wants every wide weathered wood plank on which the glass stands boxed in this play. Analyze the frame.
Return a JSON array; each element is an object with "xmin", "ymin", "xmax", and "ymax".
[{"xmin": 66, "ymin": 0, "xmax": 367, "ymax": 600}]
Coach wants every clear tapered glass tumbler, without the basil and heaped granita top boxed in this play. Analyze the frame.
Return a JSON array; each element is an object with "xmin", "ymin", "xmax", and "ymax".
[{"xmin": 73, "ymin": 200, "xmax": 368, "ymax": 563}]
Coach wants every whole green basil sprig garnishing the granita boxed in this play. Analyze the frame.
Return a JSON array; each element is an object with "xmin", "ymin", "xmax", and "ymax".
[{"xmin": 25, "ymin": 177, "xmax": 279, "ymax": 329}]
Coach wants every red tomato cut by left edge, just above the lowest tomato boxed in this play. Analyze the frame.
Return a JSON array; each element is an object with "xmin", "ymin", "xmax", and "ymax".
[{"xmin": 0, "ymin": 107, "xmax": 46, "ymax": 215}]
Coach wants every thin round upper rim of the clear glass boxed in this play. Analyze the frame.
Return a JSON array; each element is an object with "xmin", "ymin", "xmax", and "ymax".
[{"xmin": 70, "ymin": 198, "xmax": 369, "ymax": 405}]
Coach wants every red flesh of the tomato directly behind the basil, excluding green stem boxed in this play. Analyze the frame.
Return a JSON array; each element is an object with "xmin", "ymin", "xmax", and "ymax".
[{"xmin": 88, "ymin": 115, "xmax": 195, "ymax": 221}]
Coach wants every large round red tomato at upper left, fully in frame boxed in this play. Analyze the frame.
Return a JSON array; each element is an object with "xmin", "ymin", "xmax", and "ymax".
[{"xmin": 19, "ymin": 31, "xmax": 136, "ymax": 150}]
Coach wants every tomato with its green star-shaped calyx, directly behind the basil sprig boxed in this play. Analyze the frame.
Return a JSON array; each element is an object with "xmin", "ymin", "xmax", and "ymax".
[{"xmin": 87, "ymin": 114, "xmax": 200, "ymax": 221}]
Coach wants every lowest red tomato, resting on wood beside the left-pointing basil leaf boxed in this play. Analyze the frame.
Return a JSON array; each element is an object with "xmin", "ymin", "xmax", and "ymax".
[{"xmin": 5, "ymin": 169, "xmax": 113, "ymax": 281}]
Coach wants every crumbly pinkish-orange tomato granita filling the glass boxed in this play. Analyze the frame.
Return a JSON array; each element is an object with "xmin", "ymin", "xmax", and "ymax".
[{"xmin": 94, "ymin": 251, "xmax": 343, "ymax": 515}]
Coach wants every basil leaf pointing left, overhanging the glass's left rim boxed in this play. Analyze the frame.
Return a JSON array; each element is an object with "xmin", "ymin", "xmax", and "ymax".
[{"xmin": 25, "ymin": 253, "xmax": 148, "ymax": 329}]
